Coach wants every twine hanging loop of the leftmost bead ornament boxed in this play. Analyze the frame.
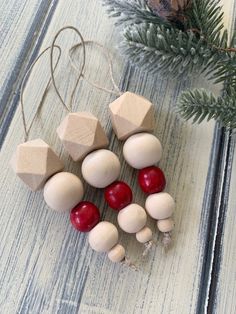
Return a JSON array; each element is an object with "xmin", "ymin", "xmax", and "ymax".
[{"xmin": 20, "ymin": 45, "xmax": 61, "ymax": 142}]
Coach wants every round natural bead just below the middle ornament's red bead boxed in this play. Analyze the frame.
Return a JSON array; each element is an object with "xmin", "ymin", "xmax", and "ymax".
[{"xmin": 117, "ymin": 204, "xmax": 147, "ymax": 233}]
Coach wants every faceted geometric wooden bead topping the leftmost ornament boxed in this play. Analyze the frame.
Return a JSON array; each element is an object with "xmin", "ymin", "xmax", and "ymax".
[{"xmin": 10, "ymin": 139, "xmax": 64, "ymax": 191}]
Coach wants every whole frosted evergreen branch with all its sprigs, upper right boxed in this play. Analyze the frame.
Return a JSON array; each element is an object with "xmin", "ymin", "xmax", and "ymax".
[{"xmin": 103, "ymin": 0, "xmax": 236, "ymax": 128}]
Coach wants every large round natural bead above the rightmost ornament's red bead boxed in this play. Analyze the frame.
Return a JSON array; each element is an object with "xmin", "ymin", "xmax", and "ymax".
[{"xmin": 123, "ymin": 133, "xmax": 162, "ymax": 169}]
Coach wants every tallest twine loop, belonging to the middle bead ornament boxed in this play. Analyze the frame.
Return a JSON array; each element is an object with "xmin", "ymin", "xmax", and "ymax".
[{"xmin": 50, "ymin": 26, "xmax": 86, "ymax": 112}]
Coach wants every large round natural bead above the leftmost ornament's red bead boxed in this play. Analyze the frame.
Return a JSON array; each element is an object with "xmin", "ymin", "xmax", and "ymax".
[{"xmin": 43, "ymin": 172, "xmax": 84, "ymax": 212}]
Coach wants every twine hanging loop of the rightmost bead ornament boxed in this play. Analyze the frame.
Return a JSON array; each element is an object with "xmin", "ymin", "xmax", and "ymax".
[{"xmin": 69, "ymin": 40, "xmax": 122, "ymax": 96}]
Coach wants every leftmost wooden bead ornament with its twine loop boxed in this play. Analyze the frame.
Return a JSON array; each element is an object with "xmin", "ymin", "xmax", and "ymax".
[{"xmin": 11, "ymin": 38, "xmax": 130, "ymax": 264}]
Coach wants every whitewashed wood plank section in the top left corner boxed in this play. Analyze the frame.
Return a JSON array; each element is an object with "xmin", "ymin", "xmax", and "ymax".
[{"xmin": 0, "ymin": 0, "xmax": 53, "ymax": 98}]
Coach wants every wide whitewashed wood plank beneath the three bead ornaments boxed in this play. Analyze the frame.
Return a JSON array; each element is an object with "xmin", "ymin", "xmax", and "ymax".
[{"xmin": 0, "ymin": 0, "xmax": 234, "ymax": 314}]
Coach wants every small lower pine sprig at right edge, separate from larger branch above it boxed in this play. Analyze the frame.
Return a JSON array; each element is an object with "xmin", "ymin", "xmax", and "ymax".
[{"xmin": 178, "ymin": 89, "xmax": 236, "ymax": 128}]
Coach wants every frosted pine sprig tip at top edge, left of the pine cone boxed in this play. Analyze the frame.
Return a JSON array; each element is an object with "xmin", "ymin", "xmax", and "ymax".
[{"xmin": 103, "ymin": 0, "xmax": 169, "ymax": 26}]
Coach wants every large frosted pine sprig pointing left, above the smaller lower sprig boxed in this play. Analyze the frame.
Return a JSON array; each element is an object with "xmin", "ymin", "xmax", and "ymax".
[{"xmin": 121, "ymin": 23, "xmax": 219, "ymax": 76}]
